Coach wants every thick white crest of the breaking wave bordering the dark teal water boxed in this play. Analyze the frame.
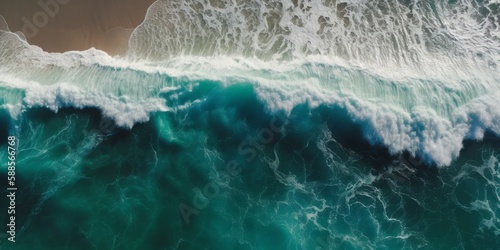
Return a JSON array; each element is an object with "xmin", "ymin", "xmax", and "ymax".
[{"xmin": 0, "ymin": 45, "xmax": 500, "ymax": 166}]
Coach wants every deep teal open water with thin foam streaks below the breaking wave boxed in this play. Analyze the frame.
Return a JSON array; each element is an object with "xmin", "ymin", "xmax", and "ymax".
[{"xmin": 1, "ymin": 84, "xmax": 500, "ymax": 249}]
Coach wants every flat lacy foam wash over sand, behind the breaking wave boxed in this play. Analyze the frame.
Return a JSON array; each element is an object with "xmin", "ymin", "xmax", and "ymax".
[{"xmin": 129, "ymin": 0, "xmax": 500, "ymax": 79}]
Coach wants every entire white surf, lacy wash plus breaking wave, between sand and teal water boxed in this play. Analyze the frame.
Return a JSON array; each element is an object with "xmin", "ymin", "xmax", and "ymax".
[{"xmin": 0, "ymin": 1, "xmax": 500, "ymax": 166}]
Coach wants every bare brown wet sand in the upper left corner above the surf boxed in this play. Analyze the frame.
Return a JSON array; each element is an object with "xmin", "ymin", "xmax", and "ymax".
[{"xmin": 0, "ymin": 0, "xmax": 154, "ymax": 55}]
